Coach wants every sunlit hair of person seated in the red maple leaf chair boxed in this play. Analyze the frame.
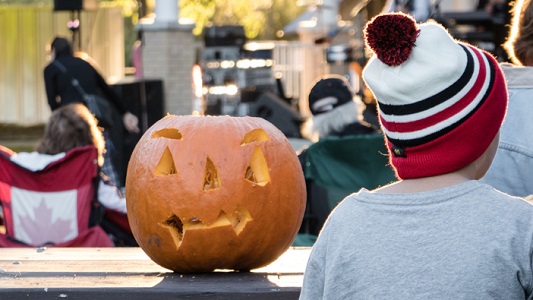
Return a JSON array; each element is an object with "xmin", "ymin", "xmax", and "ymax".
[{"xmin": 37, "ymin": 103, "xmax": 105, "ymax": 166}]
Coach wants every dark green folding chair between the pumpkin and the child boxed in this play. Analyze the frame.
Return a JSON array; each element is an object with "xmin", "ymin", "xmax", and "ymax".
[{"xmin": 299, "ymin": 134, "xmax": 396, "ymax": 239}]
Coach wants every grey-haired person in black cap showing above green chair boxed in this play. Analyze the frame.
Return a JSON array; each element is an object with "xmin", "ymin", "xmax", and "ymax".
[{"xmin": 301, "ymin": 74, "xmax": 379, "ymax": 142}]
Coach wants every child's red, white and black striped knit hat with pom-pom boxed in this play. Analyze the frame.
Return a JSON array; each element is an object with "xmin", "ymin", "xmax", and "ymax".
[{"xmin": 363, "ymin": 13, "xmax": 508, "ymax": 179}]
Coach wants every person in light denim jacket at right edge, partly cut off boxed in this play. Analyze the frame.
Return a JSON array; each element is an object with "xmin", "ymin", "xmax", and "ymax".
[{"xmin": 482, "ymin": 0, "xmax": 533, "ymax": 197}]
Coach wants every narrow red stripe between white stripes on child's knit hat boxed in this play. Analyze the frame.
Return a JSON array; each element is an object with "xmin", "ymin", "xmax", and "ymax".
[{"xmin": 380, "ymin": 46, "xmax": 487, "ymax": 135}]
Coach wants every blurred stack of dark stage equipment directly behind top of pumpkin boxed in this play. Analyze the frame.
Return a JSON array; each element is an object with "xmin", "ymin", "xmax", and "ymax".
[{"xmin": 199, "ymin": 26, "xmax": 302, "ymax": 137}]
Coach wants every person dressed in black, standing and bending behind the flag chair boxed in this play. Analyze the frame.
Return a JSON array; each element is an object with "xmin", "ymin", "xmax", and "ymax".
[{"xmin": 44, "ymin": 37, "xmax": 139, "ymax": 185}]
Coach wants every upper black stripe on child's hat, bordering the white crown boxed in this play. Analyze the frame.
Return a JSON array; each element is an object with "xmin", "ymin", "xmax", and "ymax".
[{"xmin": 379, "ymin": 44, "xmax": 474, "ymax": 116}]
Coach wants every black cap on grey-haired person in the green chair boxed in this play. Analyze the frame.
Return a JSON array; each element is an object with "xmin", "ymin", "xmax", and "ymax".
[{"xmin": 309, "ymin": 74, "xmax": 354, "ymax": 116}]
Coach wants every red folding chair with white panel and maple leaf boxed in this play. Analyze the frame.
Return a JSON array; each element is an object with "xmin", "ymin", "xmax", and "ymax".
[{"xmin": 0, "ymin": 146, "xmax": 113, "ymax": 247}]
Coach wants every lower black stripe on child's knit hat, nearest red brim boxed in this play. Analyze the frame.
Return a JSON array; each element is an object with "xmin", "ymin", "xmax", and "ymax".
[{"xmin": 387, "ymin": 48, "xmax": 496, "ymax": 148}]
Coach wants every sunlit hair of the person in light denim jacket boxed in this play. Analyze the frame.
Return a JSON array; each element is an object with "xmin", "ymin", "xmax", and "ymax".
[{"xmin": 504, "ymin": 0, "xmax": 533, "ymax": 66}]
